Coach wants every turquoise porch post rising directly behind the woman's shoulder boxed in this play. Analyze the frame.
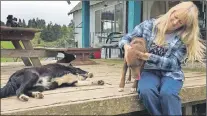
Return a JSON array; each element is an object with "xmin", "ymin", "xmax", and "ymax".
[{"xmin": 128, "ymin": 0, "xmax": 142, "ymax": 32}]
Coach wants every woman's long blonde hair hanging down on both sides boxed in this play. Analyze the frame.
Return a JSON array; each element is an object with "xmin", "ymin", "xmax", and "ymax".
[{"xmin": 153, "ymin": 1, "xmax": 206, "ymax": 63}]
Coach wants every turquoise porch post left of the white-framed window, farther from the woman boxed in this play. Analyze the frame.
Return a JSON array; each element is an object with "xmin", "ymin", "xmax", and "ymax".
[{"xmin": 82, "ymin": 1, "xmax": 90, "ymax": 48}]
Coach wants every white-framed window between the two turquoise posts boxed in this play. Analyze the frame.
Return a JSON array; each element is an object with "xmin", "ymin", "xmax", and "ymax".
[{"xmin": 95, "ymin": 3, "xmax": 124, "ymax": 34}]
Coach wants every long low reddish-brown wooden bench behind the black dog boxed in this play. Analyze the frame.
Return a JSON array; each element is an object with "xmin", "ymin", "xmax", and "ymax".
[{"xmin": 35, "ymin": 48, "xmax": 101, "ymax": 65}]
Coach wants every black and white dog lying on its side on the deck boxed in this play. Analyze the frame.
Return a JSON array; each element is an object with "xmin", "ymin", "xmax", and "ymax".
[{"xmin": 0, "ymin": 63, "xmax": 104, "ymax": 101}]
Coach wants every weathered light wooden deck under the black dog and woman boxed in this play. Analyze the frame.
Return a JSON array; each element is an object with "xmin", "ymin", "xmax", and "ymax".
[{"xmin": 1, "ymin": 59, "xmax": 206, "ymax": 115}]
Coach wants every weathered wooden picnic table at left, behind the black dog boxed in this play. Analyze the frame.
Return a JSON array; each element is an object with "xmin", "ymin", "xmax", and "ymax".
[{"xmin": 0, "ymin": 26, "xmax": 45, "ymax": 66}]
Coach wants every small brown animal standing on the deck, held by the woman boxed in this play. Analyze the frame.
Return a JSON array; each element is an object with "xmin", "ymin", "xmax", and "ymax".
[{"xmin": 119, "ymin": 38, "xmax": 147, "ymax": 92}]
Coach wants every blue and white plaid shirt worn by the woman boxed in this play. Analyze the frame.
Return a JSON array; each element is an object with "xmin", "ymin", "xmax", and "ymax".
[{"xmin": 119, "ymin": 19, "xmax": 187, "ymax": 81}]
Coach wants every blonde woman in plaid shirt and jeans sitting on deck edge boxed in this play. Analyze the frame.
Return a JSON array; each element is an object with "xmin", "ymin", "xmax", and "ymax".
[{"xmin": 119, "ymin": 1, "xmax": 205, "ymax": 115}]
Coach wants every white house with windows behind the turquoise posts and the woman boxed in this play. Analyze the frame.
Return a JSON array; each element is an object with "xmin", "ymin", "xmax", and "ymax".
[{"xmin": 68, "ymin": 0, "xmax": 206, "ymax": 57}]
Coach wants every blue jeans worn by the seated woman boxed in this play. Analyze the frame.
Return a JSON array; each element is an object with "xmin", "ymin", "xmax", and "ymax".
[{"xmin": 138, "ymin": 71, "xmax": 183, "ymax": 116}]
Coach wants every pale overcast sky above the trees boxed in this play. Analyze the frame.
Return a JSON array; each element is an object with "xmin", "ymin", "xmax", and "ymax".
[{"xmin": 1, "ymin": 1, "xmax": 80, "ymax": 25}]
